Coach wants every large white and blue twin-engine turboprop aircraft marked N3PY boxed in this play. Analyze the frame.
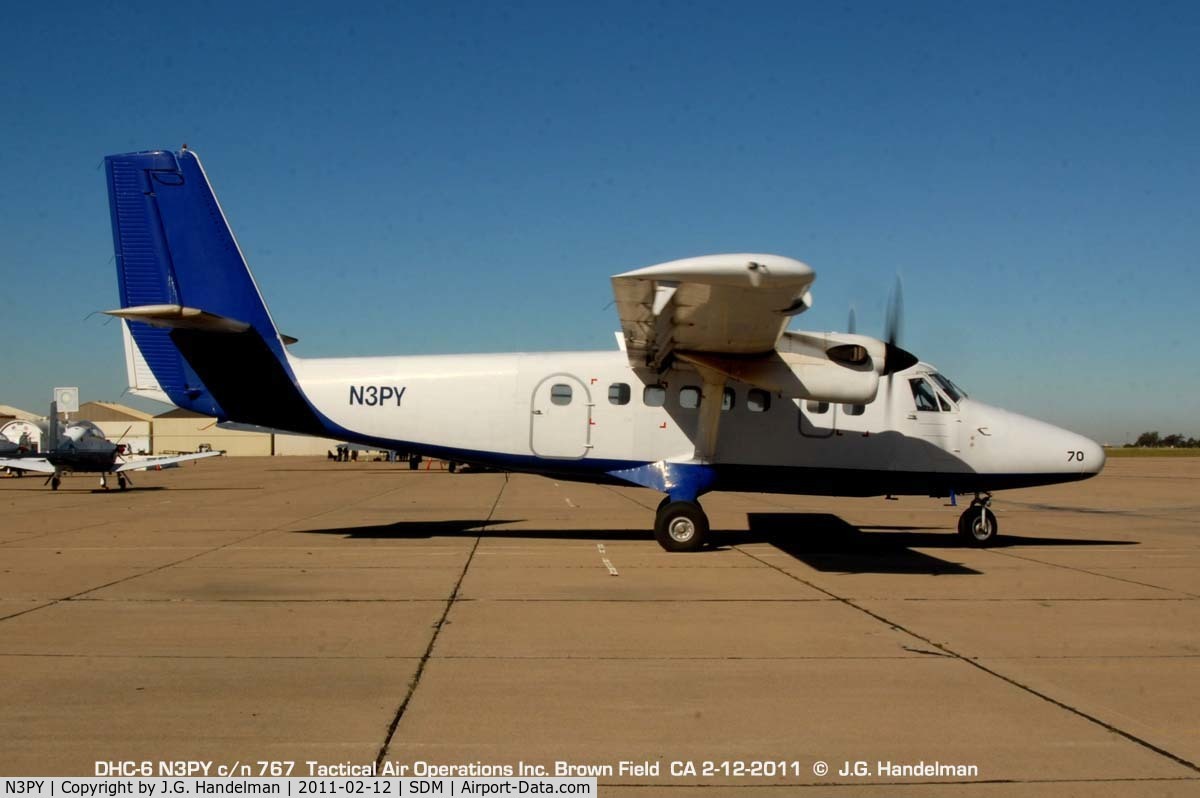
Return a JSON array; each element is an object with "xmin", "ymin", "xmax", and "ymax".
[{"xmin": 98, "ymin": 149, "xmax": 1104, "ymax": 551}]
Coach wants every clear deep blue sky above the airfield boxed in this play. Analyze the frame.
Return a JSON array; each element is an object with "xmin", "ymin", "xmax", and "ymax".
[{"xmin": 0, "ymin": 2, "xmax": 1200, "ymax": 442}]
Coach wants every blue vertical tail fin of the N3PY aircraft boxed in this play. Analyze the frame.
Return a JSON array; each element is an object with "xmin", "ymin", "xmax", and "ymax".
[{"xmin": 104, "ymin": 150, "xmax": 324, "ymax": 433}]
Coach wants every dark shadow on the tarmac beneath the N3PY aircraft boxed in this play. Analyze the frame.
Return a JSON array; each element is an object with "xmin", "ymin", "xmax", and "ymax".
[{"xmin": 296, "ymin": 512, "xmax": 1136, "ymax": 576}]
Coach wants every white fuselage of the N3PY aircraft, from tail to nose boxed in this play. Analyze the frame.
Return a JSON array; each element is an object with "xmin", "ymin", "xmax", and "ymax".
[{"xmin": 289, "ymin": 352, "xmax": 1104, "ymax": 494}]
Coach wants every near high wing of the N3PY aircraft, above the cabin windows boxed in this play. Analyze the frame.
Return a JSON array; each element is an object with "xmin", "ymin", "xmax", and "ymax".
[{"xmin": 612, "ymin": 253, "xmax": 816, "ymax": 371}]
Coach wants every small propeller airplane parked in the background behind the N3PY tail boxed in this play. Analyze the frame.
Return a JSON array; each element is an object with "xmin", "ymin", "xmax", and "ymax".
[{"xmin": 0, "ymin": 404, "xmax": 223, "ymax": 491}]
